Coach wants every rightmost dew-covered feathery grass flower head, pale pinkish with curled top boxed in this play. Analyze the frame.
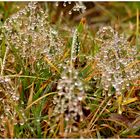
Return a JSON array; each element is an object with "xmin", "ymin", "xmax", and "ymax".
[{"xmin": 95, "ymin": 26, "xmax": 140, "ymax": 114}]
